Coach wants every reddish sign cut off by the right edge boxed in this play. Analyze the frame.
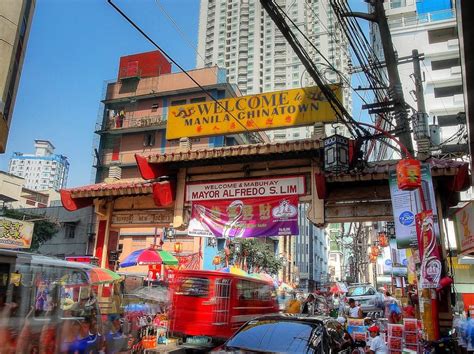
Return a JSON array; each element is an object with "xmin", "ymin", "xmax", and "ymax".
[{"xmin": 453, "ymin": 201, "xmax": 474, "ymax": 254}]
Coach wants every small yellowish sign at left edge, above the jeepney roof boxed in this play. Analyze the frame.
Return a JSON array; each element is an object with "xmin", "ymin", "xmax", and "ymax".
[{"xmin": 0, "ymin": 217, "xmax": 35, "ymax": 248}]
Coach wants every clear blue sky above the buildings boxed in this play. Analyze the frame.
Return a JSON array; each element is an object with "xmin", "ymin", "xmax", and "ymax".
[{"xmin": 0, "ymin": 0, "xmax": 364, "ymax": 187}]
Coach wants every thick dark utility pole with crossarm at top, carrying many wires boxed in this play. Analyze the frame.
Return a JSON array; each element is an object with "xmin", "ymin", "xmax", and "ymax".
[{"xmin": 344, "ymin": 0, "xmax": 413, "ymax": 155}]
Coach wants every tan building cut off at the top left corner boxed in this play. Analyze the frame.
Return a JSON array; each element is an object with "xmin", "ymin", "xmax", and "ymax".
[{"xmin": 0, "ymin": 0, "xmax": 35, "ymax": 153}]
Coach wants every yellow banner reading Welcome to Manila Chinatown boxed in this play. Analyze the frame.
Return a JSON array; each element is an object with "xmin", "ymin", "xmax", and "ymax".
[{"xmin": 166, "ymin": 85, "xmax": 342, "ymax": 140}]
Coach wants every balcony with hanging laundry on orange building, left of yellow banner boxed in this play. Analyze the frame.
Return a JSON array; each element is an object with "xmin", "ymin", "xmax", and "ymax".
[{"xmin": 96, "ymin": 115, "xmax": 166, "ymax": 133}]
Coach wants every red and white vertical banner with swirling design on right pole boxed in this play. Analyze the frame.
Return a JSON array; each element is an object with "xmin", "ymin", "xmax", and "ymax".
[{"xmin": 416, "ymin": 210, "xmax": 441, "ymax": 289}]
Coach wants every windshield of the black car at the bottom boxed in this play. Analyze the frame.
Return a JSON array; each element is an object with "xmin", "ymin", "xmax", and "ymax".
[{"xmin": 226, "ymin": 320, "xmax": 323, "ymax": 353}]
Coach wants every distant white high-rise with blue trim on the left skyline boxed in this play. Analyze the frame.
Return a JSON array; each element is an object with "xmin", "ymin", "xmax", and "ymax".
[{"xmin": 8, "ymin": 140, "xmax": 69, "ymax": 191}]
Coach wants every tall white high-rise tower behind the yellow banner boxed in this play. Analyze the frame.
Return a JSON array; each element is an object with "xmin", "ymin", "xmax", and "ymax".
[{"xmin": 197, "ymin": 0, "xmax": 352, "ymax": 140}]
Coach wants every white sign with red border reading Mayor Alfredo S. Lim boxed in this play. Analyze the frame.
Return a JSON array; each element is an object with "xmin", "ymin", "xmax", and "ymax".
[{"xmin": 186, "ymin": 176, "xmax": 306, "ymax": 202}]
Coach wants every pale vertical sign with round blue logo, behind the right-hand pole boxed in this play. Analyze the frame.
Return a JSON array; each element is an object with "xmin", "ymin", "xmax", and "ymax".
[{"xmin": 388, "ymin": 164, "xmax": 439, "ymax": 249}]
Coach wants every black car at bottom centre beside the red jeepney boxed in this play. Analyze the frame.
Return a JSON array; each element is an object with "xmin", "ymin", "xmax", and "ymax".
[{"xmin": 213, "ymin": 314, "xmax": 351, "ymax": 354}]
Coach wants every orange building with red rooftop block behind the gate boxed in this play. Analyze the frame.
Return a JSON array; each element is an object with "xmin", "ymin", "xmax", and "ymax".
[{"xmin": 94, "ymin": 51, "xmax": 260, "ymax": 274}]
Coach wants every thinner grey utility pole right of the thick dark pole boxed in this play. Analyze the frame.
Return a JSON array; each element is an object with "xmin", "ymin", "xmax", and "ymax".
[{"xmin": 412, "ymin": 49, "xmax": 431, "ymax": 160}]
